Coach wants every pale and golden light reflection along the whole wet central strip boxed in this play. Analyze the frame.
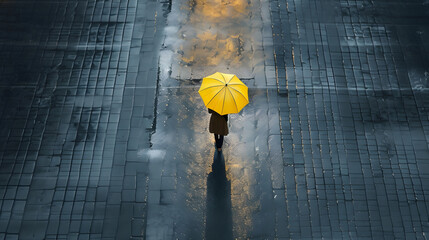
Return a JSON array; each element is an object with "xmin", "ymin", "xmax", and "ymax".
[{"xmin": 158, "ymin": 0, "xmax": 263, "ymax": 235}]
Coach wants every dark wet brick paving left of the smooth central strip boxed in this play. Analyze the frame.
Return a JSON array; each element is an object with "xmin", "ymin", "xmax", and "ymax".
[{"xmin": 0, "ymin": 0, "xmax": 163, "ymax": 239}]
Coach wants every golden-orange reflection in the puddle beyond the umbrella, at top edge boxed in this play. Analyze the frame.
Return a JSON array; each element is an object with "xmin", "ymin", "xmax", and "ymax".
[{"xmin": 179, "ymin": 0, "xmax": 252, "ymax": 67}]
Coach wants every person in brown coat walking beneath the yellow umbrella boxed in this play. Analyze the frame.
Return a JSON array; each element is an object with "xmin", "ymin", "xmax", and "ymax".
[{"xmin": 209, "ymin": 109, "xmax": 229, "ymax": 152}]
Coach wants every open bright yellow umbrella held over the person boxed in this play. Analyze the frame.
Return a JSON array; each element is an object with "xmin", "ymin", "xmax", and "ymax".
[{"xmin": 198, "ymin": 72, "xmax": 249, "ymax": 115}]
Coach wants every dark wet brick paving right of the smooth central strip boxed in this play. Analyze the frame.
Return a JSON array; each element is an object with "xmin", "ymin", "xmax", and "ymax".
[{"xmin": 270, "ymin": 0, "xmax": 429, "ymax": 239}]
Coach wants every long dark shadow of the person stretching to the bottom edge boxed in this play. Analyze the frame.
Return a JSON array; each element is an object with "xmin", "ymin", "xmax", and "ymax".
[{"xmin": 206, "ymin": 151, "xmax": 233, "ymax": 240}]
